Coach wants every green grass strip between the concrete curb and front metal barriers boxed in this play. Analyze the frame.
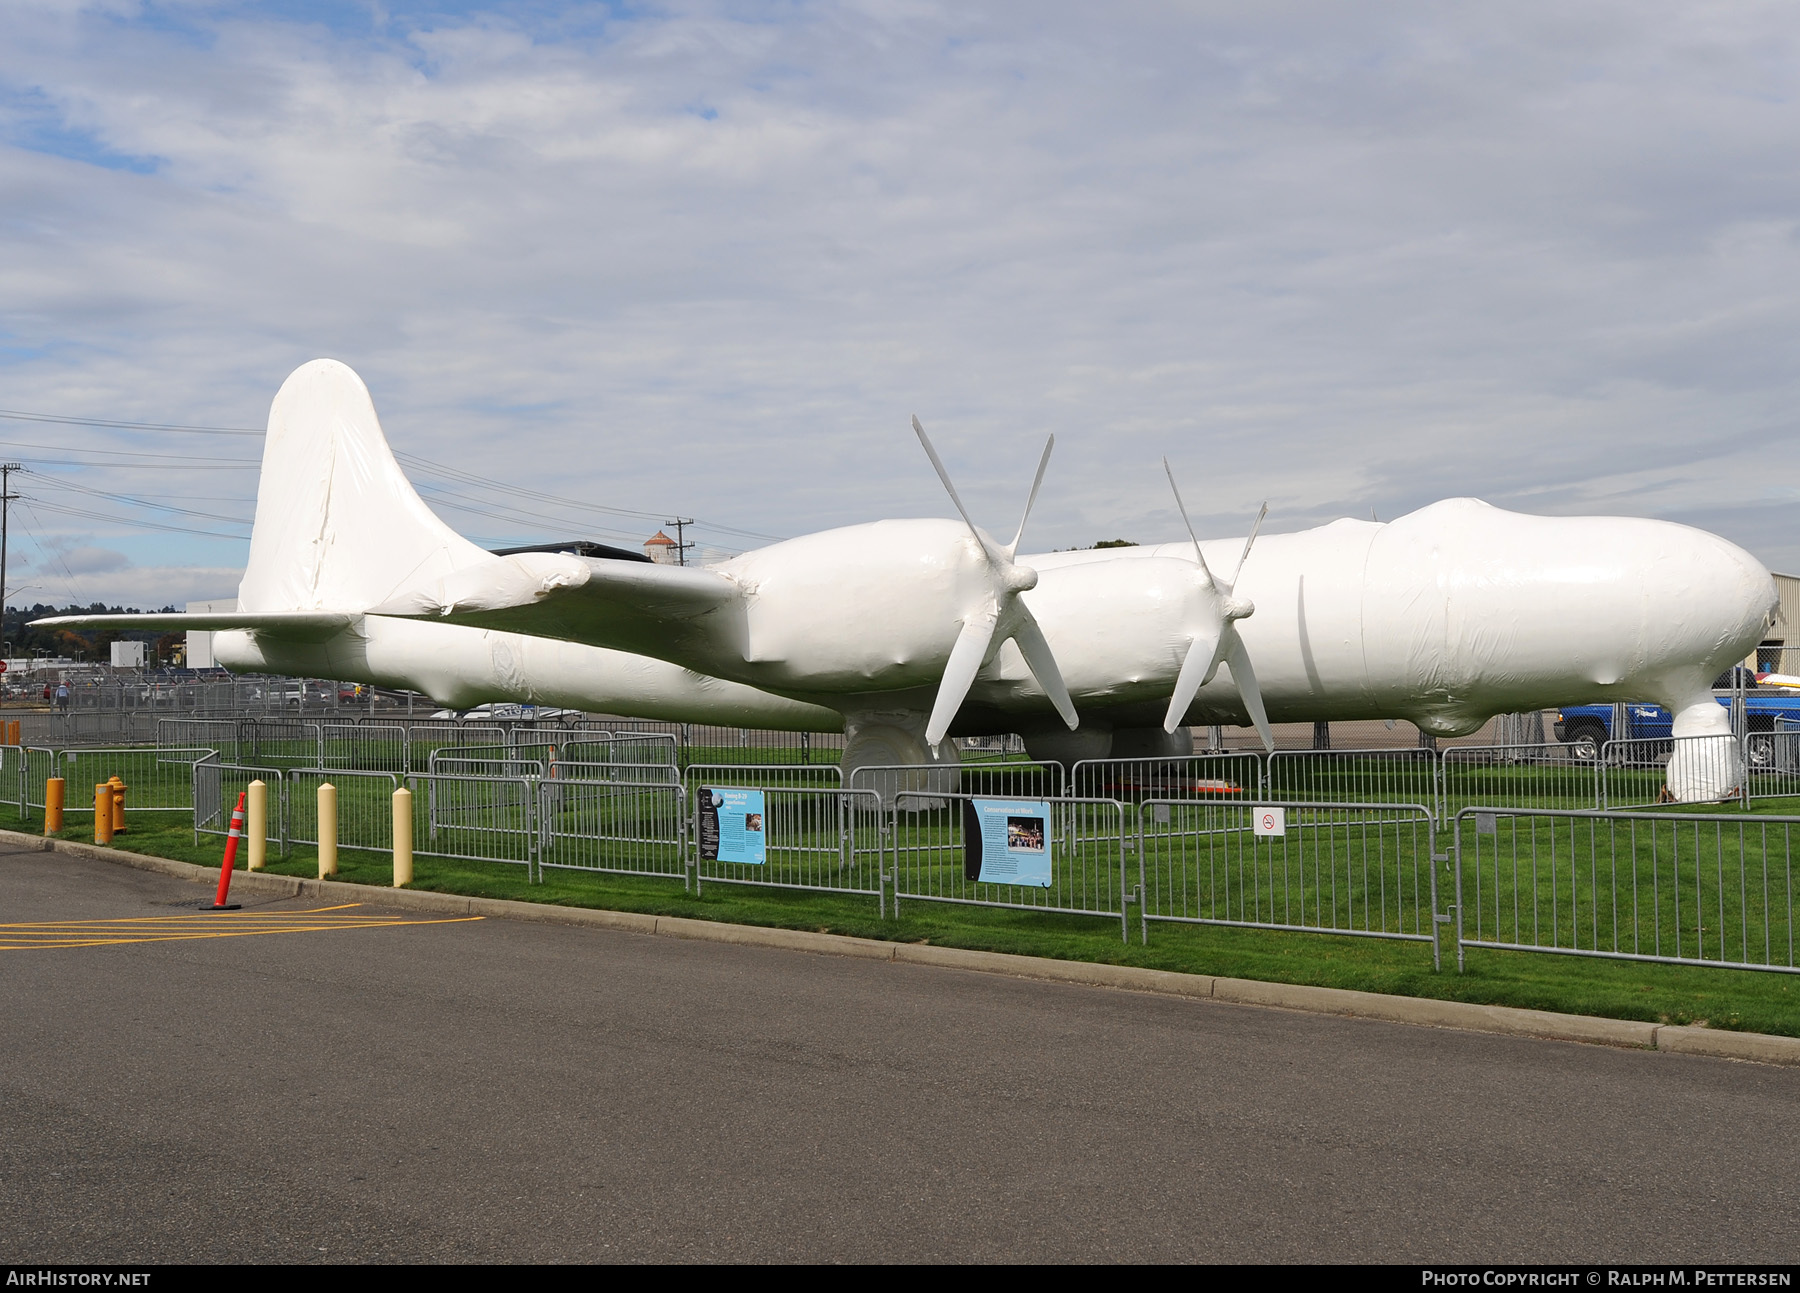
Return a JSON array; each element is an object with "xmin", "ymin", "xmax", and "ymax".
[{"xmin": 9, "ymin": 812, "xmax": 1800, "ymax": 1035}]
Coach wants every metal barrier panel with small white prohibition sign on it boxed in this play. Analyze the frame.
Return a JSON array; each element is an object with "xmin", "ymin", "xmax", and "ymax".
[{"xmin": 1138, "ymin": 800, "xmax": 1438, "ymax": 965}]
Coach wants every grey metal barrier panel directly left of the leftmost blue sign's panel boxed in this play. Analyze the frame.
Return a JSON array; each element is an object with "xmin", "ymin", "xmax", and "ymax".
[{"xmin": 538, "ymin": 764, "xmax": 688, "ymax": 886}]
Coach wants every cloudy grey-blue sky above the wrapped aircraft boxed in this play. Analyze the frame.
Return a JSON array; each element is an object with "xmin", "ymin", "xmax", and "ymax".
[{"xmin": 0, "ymin": 0, "xmax": 1800, "ymax": 605}]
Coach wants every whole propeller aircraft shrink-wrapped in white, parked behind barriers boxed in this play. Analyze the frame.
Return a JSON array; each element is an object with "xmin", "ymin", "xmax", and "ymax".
[{"xmin": 40, "ymin": 360, "xmax": 1777, "ymax": 800}]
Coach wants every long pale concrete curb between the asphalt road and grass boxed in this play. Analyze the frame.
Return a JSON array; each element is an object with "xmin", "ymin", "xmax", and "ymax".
[{"xmin": 17, "ymin": 830, "xmax": 1800, "ymax": 1066}]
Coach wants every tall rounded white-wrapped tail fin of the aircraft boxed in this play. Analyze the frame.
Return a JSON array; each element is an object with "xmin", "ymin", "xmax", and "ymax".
[{"xmin": 238, "ymin": 358, "xmax": 493, "ymax": 612}]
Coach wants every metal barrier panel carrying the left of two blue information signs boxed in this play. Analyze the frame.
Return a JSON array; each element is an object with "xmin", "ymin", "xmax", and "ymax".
[{"xmin": 688, "ymin": 782, "xmax": 887, "ymax": 915}]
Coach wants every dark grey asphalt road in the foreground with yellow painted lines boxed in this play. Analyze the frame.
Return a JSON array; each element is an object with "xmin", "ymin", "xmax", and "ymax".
[{"xmin": 0, "ymin": 852, "xmax": 1800, "ymax": 1262}]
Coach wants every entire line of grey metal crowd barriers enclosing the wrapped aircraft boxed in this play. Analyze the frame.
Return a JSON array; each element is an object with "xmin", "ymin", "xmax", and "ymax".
[{"xmin": 14, "ymin": 729, "xmax": 1800, "ymax": 971}]
